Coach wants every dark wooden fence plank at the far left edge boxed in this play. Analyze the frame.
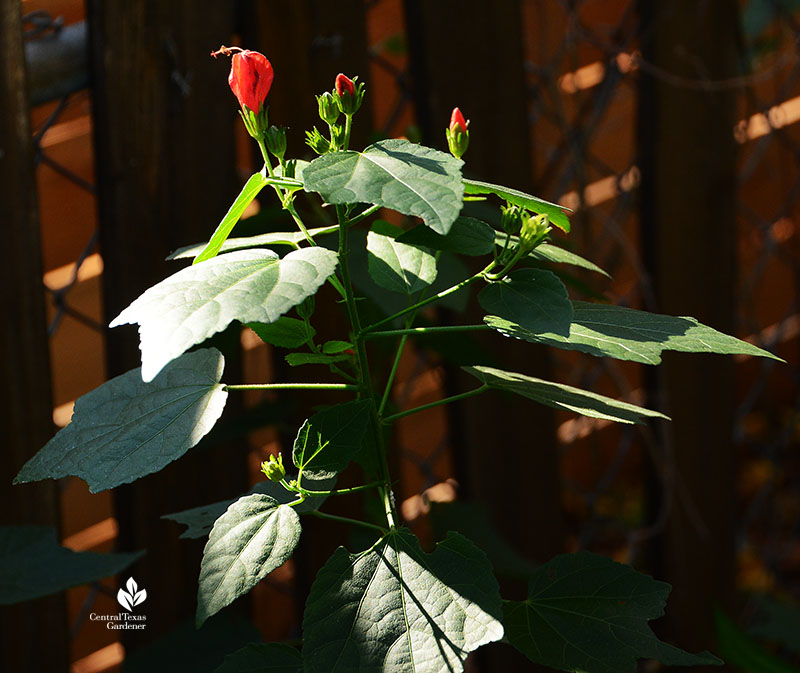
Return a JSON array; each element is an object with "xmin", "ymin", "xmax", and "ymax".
[{"xmin": 0, "ymin": 0, "xmax": 69, "ymax": 671}]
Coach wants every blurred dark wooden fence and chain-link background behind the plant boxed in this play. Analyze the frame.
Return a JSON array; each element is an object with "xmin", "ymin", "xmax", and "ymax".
[{"xmin": 0, "ymin": 0, "xmax": 800, "ymax": 673}]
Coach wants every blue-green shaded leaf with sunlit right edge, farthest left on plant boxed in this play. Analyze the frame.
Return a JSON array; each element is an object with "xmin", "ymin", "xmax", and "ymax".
[{"xmin": 14, "ymin": 348, "xmax": 228, "ymax": 493}]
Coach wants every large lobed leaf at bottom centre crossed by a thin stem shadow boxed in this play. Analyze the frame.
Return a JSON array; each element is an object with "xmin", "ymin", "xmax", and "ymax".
[{"xmin": 303, "ymin": 529, "xmax": 503, "ymax": 673}]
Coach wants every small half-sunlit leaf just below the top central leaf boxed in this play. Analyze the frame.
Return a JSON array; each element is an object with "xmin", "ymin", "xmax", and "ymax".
[{"xmin": 367, "ymin": 220, "xmax": 436, "ymax": 295}]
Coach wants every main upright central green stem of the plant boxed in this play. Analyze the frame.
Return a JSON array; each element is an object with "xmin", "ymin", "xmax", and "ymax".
[{"xmin": 336, "ymin": 206, "xmax": 397, "ymax": 529}]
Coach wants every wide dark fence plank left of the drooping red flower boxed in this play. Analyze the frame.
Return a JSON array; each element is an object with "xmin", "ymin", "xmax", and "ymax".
[{"xmin": 89, "ymin": 0, "xmax": 246, "ymax": 647}]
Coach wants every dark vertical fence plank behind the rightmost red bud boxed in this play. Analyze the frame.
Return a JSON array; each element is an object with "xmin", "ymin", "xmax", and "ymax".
[{"xmin": 405, "ymin": 0, "xmax": 565, "ymax": 671}]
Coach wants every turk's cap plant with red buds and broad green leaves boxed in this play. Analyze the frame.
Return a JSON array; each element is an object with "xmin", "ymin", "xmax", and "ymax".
[{"xmin": 7, "ymin": 48, "xmax": 777, "ymax": 673}]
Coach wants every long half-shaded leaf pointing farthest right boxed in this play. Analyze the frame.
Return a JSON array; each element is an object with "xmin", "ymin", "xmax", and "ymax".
[{"xmin": 484, "ymin": 301, "xmax": 782, "ymax": 365}]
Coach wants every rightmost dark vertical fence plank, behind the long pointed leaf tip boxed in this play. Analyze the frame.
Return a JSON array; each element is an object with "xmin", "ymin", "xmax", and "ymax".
[{"xmin": 640, "ymin": 0, "xmax": 738, "ymax": 650}]
